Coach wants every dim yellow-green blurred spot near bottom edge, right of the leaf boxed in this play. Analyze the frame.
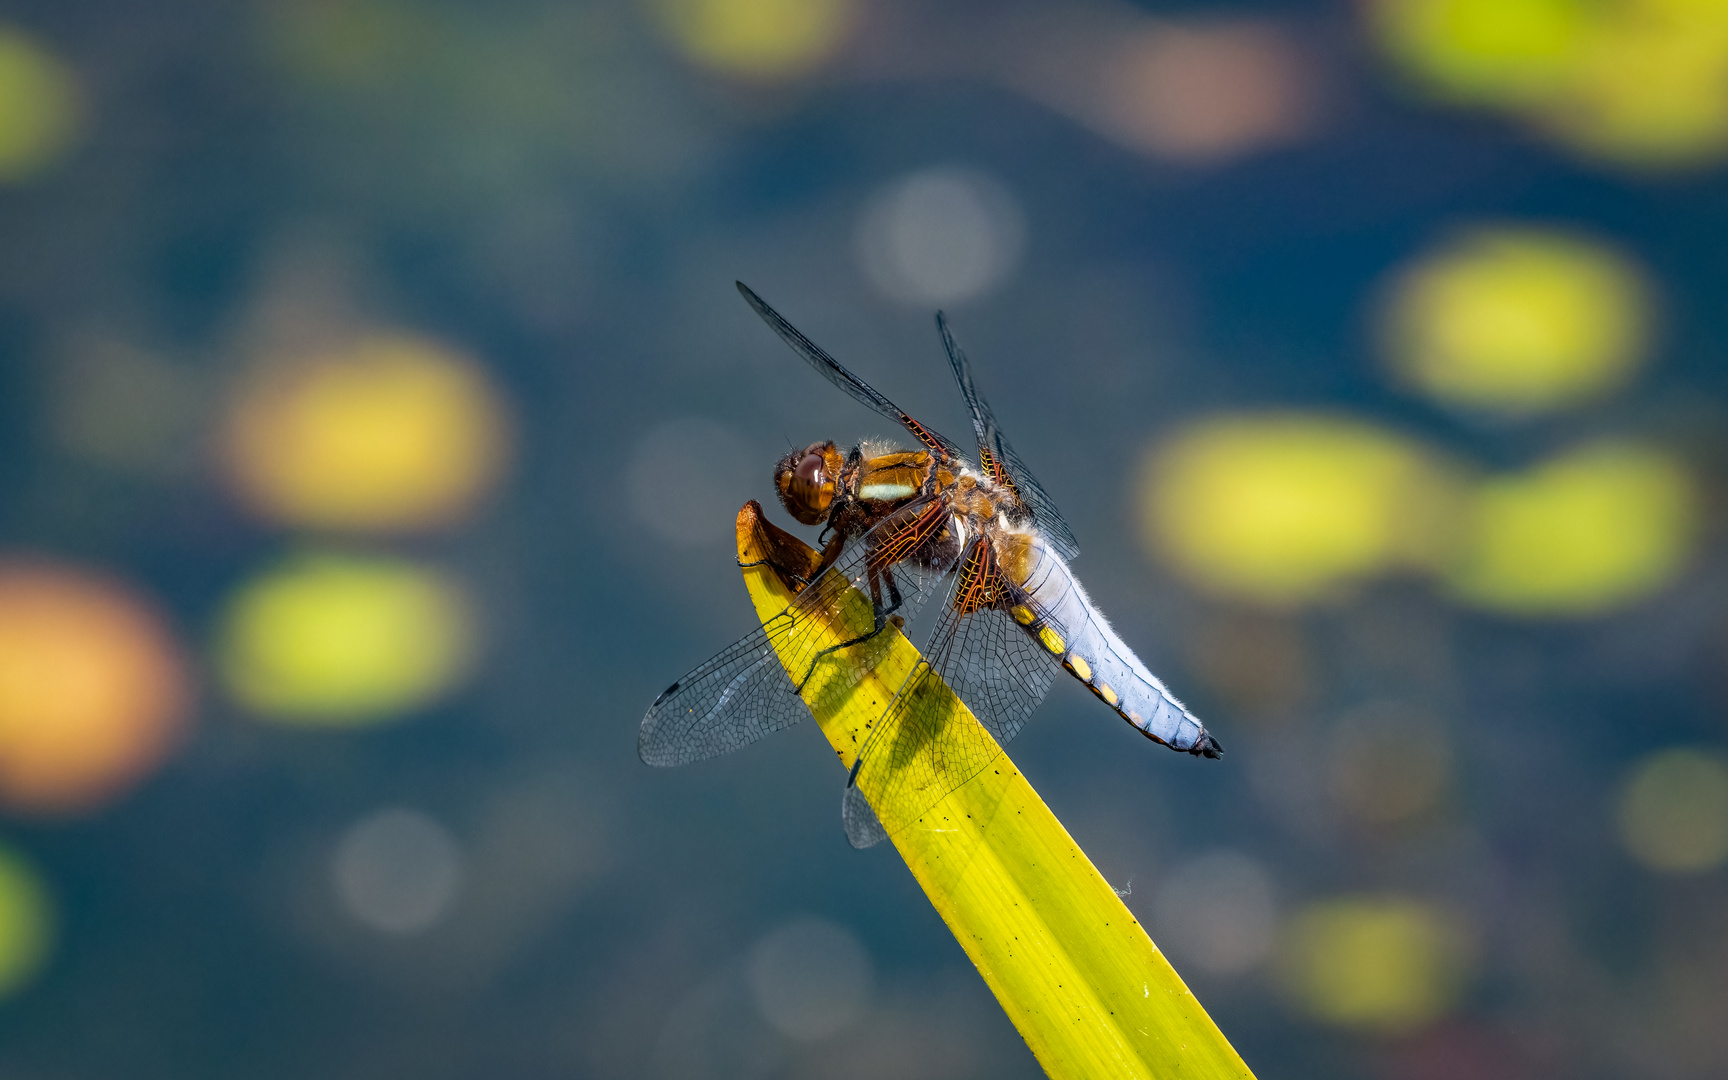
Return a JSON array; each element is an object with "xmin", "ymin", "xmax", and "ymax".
[{"xmin": 1279, "ymin": 897, "xmax": 1471, "ymax": 1033}]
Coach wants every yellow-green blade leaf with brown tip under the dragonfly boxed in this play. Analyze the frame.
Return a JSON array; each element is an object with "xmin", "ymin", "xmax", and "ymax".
[{"xmin": 738, "ymin": 503, "xmax": 1253, "ymax": 1078}]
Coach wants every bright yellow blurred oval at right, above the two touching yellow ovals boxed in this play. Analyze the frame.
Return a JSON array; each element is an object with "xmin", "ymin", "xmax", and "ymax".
[{"xmin": 1384, "ymin": 228, "xmax": 1650, "ymax": 413}]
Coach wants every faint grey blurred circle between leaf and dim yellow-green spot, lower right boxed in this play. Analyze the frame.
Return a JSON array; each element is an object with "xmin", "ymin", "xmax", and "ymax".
[{"xmin": 1153, "ymin": 850, "xmax": 1279, "ymax": 975}]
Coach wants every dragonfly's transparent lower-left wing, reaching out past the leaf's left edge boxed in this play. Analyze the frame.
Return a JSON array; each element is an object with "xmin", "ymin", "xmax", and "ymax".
[{"xmin": 636, "ymin": 498, "xmax": 949, "ymax": 766}]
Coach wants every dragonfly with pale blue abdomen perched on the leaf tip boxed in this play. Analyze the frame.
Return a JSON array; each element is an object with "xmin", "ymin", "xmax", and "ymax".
[{"xmin": 638, "ymin": 282, "xmax": 1223, "ymax": 847}]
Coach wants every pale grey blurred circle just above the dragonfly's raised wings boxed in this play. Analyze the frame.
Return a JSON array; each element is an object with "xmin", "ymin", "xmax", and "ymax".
[{"xmin": 857, "ymin": 168, "xmax": 1026, "ymax": 308}]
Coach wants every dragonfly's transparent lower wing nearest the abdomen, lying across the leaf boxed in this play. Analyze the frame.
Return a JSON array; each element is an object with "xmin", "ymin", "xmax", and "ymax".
[{"xmin": 842, "ymin": 537, "xmax": 1059, "ymax": 847}]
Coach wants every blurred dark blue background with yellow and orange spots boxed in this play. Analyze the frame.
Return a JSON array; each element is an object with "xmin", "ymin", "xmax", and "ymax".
[{"xmin": 0, "ymin": 0, "xmax": 1728, "ymax": 1080}]
